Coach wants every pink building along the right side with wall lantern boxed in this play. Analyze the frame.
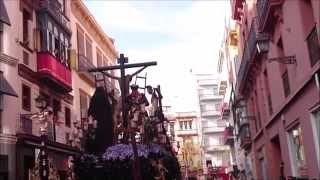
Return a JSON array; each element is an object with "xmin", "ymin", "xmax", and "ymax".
[{"xmin": 231, "ymin": 0, "xmax": 320, "ymax": 180}]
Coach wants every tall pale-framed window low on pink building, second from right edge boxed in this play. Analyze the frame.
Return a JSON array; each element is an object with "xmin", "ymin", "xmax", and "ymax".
[{"xmin": 288, "ymin": 125, "xmax": 306, "ymax": 176}]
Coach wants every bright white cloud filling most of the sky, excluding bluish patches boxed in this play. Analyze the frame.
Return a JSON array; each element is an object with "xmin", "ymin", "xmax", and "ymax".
[{"xmin": 85, "ymin": 1, "xmax": 230, "ymax": 109}]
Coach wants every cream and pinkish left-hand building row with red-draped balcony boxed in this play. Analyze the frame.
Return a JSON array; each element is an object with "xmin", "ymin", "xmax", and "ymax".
[{"xmin": 0, "ymin": 0, "xmax": 117, "ymax": 180}]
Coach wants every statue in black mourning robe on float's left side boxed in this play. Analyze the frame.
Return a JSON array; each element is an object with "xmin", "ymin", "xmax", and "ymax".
[{"xmin": 85, "ymin": 87, "xmax": 114, "ymax": 155}]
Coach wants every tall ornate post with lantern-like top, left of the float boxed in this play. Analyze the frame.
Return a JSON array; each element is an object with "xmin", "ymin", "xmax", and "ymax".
[{"xmin": 33, "ymin": 95, "xmax": 52, "ymax": 180}]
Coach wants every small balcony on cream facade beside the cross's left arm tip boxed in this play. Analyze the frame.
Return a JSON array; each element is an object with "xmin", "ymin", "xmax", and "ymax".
[{"xmin": 78, "ymin": 55, "xmax": 95, "ymax": 86}]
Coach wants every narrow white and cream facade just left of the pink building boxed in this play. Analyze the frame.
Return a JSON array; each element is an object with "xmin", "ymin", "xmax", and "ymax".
[{"xmin": 217, "ymin": 11, "xmax": 255, "ymax": 179}]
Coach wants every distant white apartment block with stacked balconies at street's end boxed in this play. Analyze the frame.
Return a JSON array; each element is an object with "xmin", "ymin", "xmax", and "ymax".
[{"xmin": 196, "ymin": 74, "xmax": 230, "ymax": 173}]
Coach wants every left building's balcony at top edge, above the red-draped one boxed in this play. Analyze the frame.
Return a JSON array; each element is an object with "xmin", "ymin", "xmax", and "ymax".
[{"xmin": 39, "ymin": 0, "xmax": 71, "ymax": 33}]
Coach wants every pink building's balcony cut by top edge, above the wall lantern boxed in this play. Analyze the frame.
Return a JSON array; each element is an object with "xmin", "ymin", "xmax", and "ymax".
[{"xmin": 256, "ymin": 0, "xmax": 283, "ymax": 32}]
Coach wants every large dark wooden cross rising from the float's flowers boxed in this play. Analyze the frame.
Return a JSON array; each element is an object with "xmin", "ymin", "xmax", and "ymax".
[{"xmin": 88, "ymin": 54, "xmax": 157, "ymax": 180}]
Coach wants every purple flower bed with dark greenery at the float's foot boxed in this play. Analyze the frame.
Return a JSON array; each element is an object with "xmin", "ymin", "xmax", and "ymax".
[{"xmin": 74, "ymin": 144, "xmax": 180, "ymax": 180}]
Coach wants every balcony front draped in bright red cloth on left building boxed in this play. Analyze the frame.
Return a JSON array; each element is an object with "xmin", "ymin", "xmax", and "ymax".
[{"xmin": 37, "ymin": 52, "xmax": 72, "ymax": 92}]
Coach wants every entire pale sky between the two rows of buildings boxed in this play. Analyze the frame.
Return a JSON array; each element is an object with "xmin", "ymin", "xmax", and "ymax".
[{"xmin": 85, "ymin": 0, "xmax": 230, "ymax": 111}]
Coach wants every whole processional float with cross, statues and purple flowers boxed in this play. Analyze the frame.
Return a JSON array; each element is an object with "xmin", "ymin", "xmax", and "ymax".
[{"xmin": 74, "ymin": 54, "xmax": 180, "ymax": 180}]
